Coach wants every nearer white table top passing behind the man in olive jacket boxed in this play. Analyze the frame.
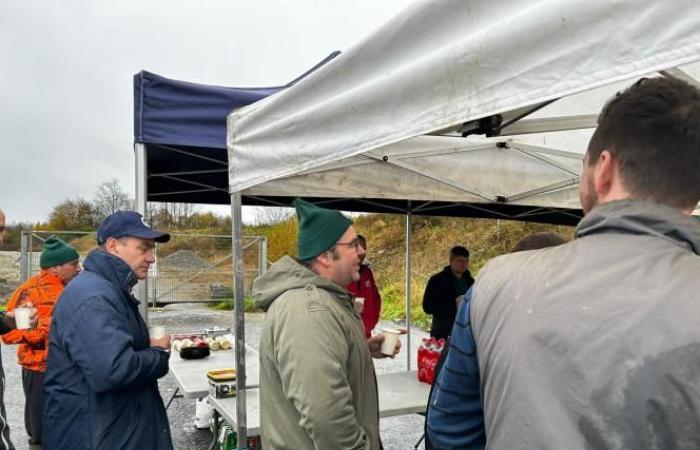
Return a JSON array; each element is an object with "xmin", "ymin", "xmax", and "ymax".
[{"xmin": 209, "ymin": 370, "xmax": 430, "ymax": 436}]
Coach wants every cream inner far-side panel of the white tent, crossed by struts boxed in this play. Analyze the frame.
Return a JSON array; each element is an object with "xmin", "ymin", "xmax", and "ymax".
[{"xmin": 245, "ymin": 136, "xmax": 581, "ymax": 213}]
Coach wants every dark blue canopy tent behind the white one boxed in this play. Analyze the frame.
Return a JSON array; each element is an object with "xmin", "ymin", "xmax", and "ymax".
[{"xmin": 134, "ymin": 51, "xmax": 340, "ymax": 204}]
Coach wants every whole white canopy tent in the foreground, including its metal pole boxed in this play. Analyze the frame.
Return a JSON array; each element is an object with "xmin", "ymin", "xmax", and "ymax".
[{"xmin": 223, "ymin": 0, "xmax": 700, "ymax": 437}]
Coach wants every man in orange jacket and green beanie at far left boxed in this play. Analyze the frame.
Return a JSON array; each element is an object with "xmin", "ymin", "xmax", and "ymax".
[{"xmin": 2, "ymin": 236, "xmax": 80, "ymax": 448}]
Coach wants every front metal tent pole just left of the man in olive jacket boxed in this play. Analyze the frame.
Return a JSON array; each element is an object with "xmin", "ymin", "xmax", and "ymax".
[{"xmin": 231, "ymin": 192, "xmax": 248, "ymax": 449}]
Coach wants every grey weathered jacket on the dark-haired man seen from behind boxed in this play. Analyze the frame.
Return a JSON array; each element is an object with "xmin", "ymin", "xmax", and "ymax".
[{"xmin": 470, "ymin": 200, "xmax": 700, "ymax": 449}]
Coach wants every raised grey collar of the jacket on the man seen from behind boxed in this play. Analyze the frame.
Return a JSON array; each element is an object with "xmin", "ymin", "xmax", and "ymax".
[{"xmin": 576, "ymin": 200, "xmax": 700, "ymax": 255}]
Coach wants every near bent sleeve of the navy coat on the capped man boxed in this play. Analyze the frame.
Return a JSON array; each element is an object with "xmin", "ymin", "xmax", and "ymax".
[{"xmin": 62, "ymin": 296, "xmax": 170, "ymax": 392}]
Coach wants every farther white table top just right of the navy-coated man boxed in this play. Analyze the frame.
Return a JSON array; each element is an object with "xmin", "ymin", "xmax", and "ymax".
[{"xmin": 170, "ymin": 348, "xmax": 260, "ymax": 398}]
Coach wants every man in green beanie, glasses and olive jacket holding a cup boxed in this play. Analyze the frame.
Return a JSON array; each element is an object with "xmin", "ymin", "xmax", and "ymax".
[{"xmin": 253, "ymin": 199, "xmax": 400, "ymax": 450}]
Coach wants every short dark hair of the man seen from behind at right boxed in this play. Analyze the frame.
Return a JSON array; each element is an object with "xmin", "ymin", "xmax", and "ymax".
[{"xmin": 587, "ymin": 77, "xmax": 700, "ymax": 209}]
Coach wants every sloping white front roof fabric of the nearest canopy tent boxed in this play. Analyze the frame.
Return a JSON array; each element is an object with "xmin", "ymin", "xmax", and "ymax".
[{"xmin": 228, "ymin": 0, "xmax": 700, "ymax": 200}]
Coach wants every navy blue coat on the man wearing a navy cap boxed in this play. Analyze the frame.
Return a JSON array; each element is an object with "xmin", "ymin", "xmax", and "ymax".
[{"xmin": 43, "ymin": 250, "xmax": 173, "ymax": 450}]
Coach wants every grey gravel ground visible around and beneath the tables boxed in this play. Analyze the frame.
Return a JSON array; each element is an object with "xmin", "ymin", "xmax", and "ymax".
[{"xmin": 2, "ymin": 304, "xmax": 426, "ymax": 450}]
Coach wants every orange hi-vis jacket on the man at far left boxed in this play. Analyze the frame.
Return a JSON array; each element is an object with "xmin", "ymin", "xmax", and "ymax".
[{"xmin": 2, "ymin": 270, "xmax": 63, "ymax": 372}]
